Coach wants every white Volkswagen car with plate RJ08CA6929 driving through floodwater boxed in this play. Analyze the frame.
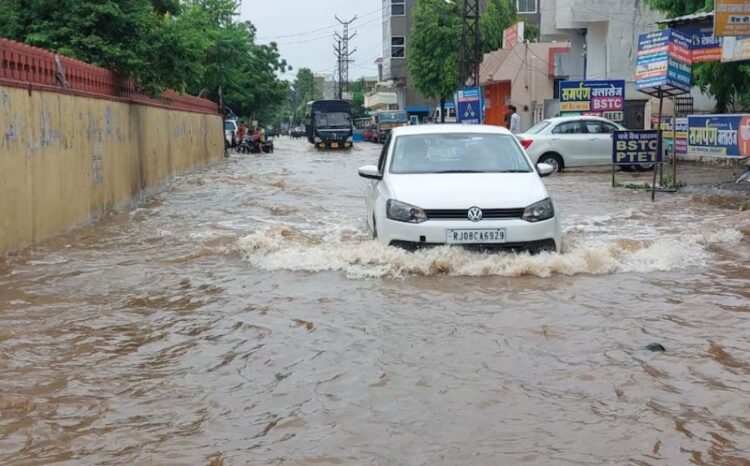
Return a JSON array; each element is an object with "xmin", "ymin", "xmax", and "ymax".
[{"xmin": 359, "ymin": 125, "xmax": 560, "ymax": 252}]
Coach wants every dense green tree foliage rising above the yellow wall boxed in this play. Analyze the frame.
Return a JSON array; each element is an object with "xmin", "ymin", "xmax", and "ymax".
[{"xmin": 0, "ymin": 0, "xmax": 289, "ymax": 118}]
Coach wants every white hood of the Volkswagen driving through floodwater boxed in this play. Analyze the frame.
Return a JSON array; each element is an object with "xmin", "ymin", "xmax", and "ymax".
[{"xmin": 388, "ymin": 173, "xmax": 548, "ymax": 209}]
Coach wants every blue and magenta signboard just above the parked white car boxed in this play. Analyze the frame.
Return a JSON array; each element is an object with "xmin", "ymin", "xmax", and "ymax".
[{"xmin": 560, "ymin": 81, "xmax": 625, "ymax": 123}]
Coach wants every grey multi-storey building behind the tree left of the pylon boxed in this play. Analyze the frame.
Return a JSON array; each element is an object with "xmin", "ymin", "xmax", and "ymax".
[{"xmin": 379, "ymin": 0, "xmax": 541, "ymax": 117}]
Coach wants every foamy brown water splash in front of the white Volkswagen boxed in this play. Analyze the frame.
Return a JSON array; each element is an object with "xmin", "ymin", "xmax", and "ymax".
[{"xmin": 238, "ymin": 226, "xmax": 742, "ymax": 278}]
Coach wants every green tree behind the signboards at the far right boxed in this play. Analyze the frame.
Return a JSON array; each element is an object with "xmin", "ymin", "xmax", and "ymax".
[{"xmin": 646, "ymin": 0, "xmax": 750, "ymax": 113}]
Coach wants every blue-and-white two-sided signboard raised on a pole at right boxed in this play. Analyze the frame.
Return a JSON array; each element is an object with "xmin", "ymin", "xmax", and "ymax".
[{"xmin": 635, "ymin": 29, "xmax": 692, "ymax": 95}]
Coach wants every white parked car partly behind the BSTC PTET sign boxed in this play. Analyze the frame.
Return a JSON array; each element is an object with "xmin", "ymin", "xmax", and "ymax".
[{"xmin": 516, "ymin": 116, "xmax": 653, "ymax": 172}]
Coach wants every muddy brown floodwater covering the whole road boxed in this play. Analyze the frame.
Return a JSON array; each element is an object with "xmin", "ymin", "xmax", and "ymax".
[{"xmin": 0, "ymin": 139, "xmax": 750, "ymax": 466}]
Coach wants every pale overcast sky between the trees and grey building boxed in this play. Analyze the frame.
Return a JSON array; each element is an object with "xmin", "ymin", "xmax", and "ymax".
[{"xmin": 241, "ymin": 0, "xmax": 383, "ymax": 80}]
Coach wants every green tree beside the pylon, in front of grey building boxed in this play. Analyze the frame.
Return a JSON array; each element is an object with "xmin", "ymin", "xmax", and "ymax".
[{"xmin": 406, "ymin": 0, "xmax": 462, "ymax": 119}]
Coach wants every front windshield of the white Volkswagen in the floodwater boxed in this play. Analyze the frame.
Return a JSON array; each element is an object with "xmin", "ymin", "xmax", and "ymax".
[{"xmin": 390, "ymin": 133, "xmax": 531, "ymax": 174}]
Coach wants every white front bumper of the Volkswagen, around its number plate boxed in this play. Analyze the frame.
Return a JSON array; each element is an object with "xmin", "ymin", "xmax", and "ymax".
[{"xmin": 378, "ymin": 215, "xmax": 561, "ymax": 252}]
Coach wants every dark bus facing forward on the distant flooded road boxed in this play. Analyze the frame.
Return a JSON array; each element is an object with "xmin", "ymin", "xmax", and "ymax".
[{"xmin": 305, "ymin": 100, "xmax": 354, "ymax": 149}]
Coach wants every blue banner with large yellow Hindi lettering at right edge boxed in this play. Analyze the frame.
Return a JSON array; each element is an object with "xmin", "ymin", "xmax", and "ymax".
[{"xmin": 688, "ymin": 114, "xmax": 750, "ymax": 157}]
